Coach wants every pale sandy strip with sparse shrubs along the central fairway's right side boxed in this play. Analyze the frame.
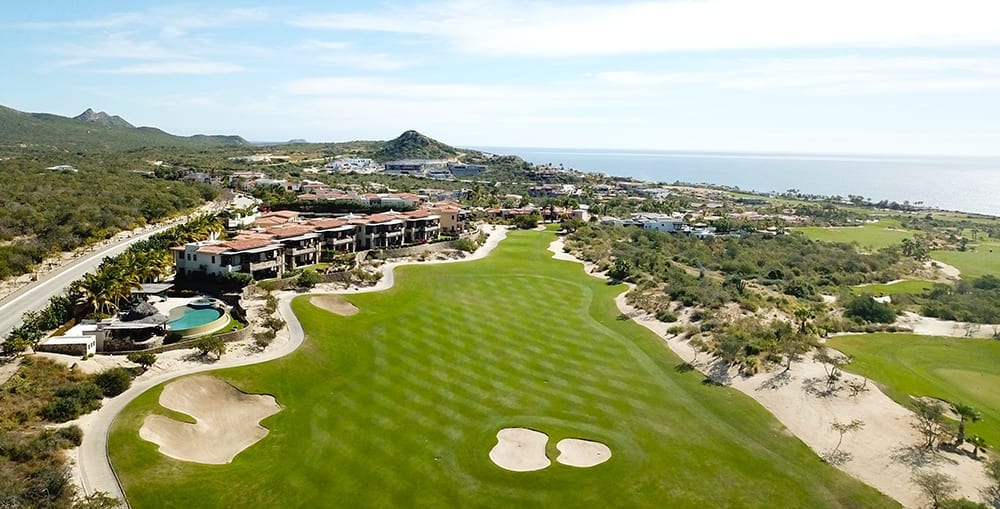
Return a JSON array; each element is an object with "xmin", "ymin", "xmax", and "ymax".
[{"xmin": 549, "ymin": 237, "xmax": 988, "ymax": 507}]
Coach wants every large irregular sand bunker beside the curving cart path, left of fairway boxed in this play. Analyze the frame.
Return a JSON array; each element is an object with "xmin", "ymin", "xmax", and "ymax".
[{"xmin": 139, "ymin": 375, "xmax": 281, "ymax": 465}]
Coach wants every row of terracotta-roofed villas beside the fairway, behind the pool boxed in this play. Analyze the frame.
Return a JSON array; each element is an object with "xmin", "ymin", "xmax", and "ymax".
[{"xmin": 172, "ymin": 202, "xmax": 470, "ymax": 279}]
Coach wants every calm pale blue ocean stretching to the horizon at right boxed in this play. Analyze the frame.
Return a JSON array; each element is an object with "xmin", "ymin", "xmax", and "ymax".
[{"xmin": 471, "ymin": 147, "xmax": 1000, "ymax": 216}]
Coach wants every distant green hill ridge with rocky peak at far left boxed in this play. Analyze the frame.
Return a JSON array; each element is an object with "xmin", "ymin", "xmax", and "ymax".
[{"xmin": 0, "ymin": 106, "xmax": 250, "ymax": 151}]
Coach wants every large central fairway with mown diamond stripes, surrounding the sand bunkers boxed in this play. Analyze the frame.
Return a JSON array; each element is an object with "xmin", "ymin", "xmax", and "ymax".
[{"xmin": 109, "ymin": 231, "xmax": 898, "ymax": 508}]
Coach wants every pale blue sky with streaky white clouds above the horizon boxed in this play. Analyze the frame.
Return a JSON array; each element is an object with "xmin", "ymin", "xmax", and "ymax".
[{"xmin": 0, "ymin": 0, "xmax": 1000, "ymax": 156}]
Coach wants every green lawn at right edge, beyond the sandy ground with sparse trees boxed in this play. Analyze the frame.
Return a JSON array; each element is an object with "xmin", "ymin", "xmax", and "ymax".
[{"xmin": 827, "ymin": 334, "xmax": 1000, "ymax": 448}]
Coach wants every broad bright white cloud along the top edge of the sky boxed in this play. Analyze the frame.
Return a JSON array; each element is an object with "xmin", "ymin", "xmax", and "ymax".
[{"xmin": 292, "ymin": 0, "xmax": 1000, "ymax": 57}]
